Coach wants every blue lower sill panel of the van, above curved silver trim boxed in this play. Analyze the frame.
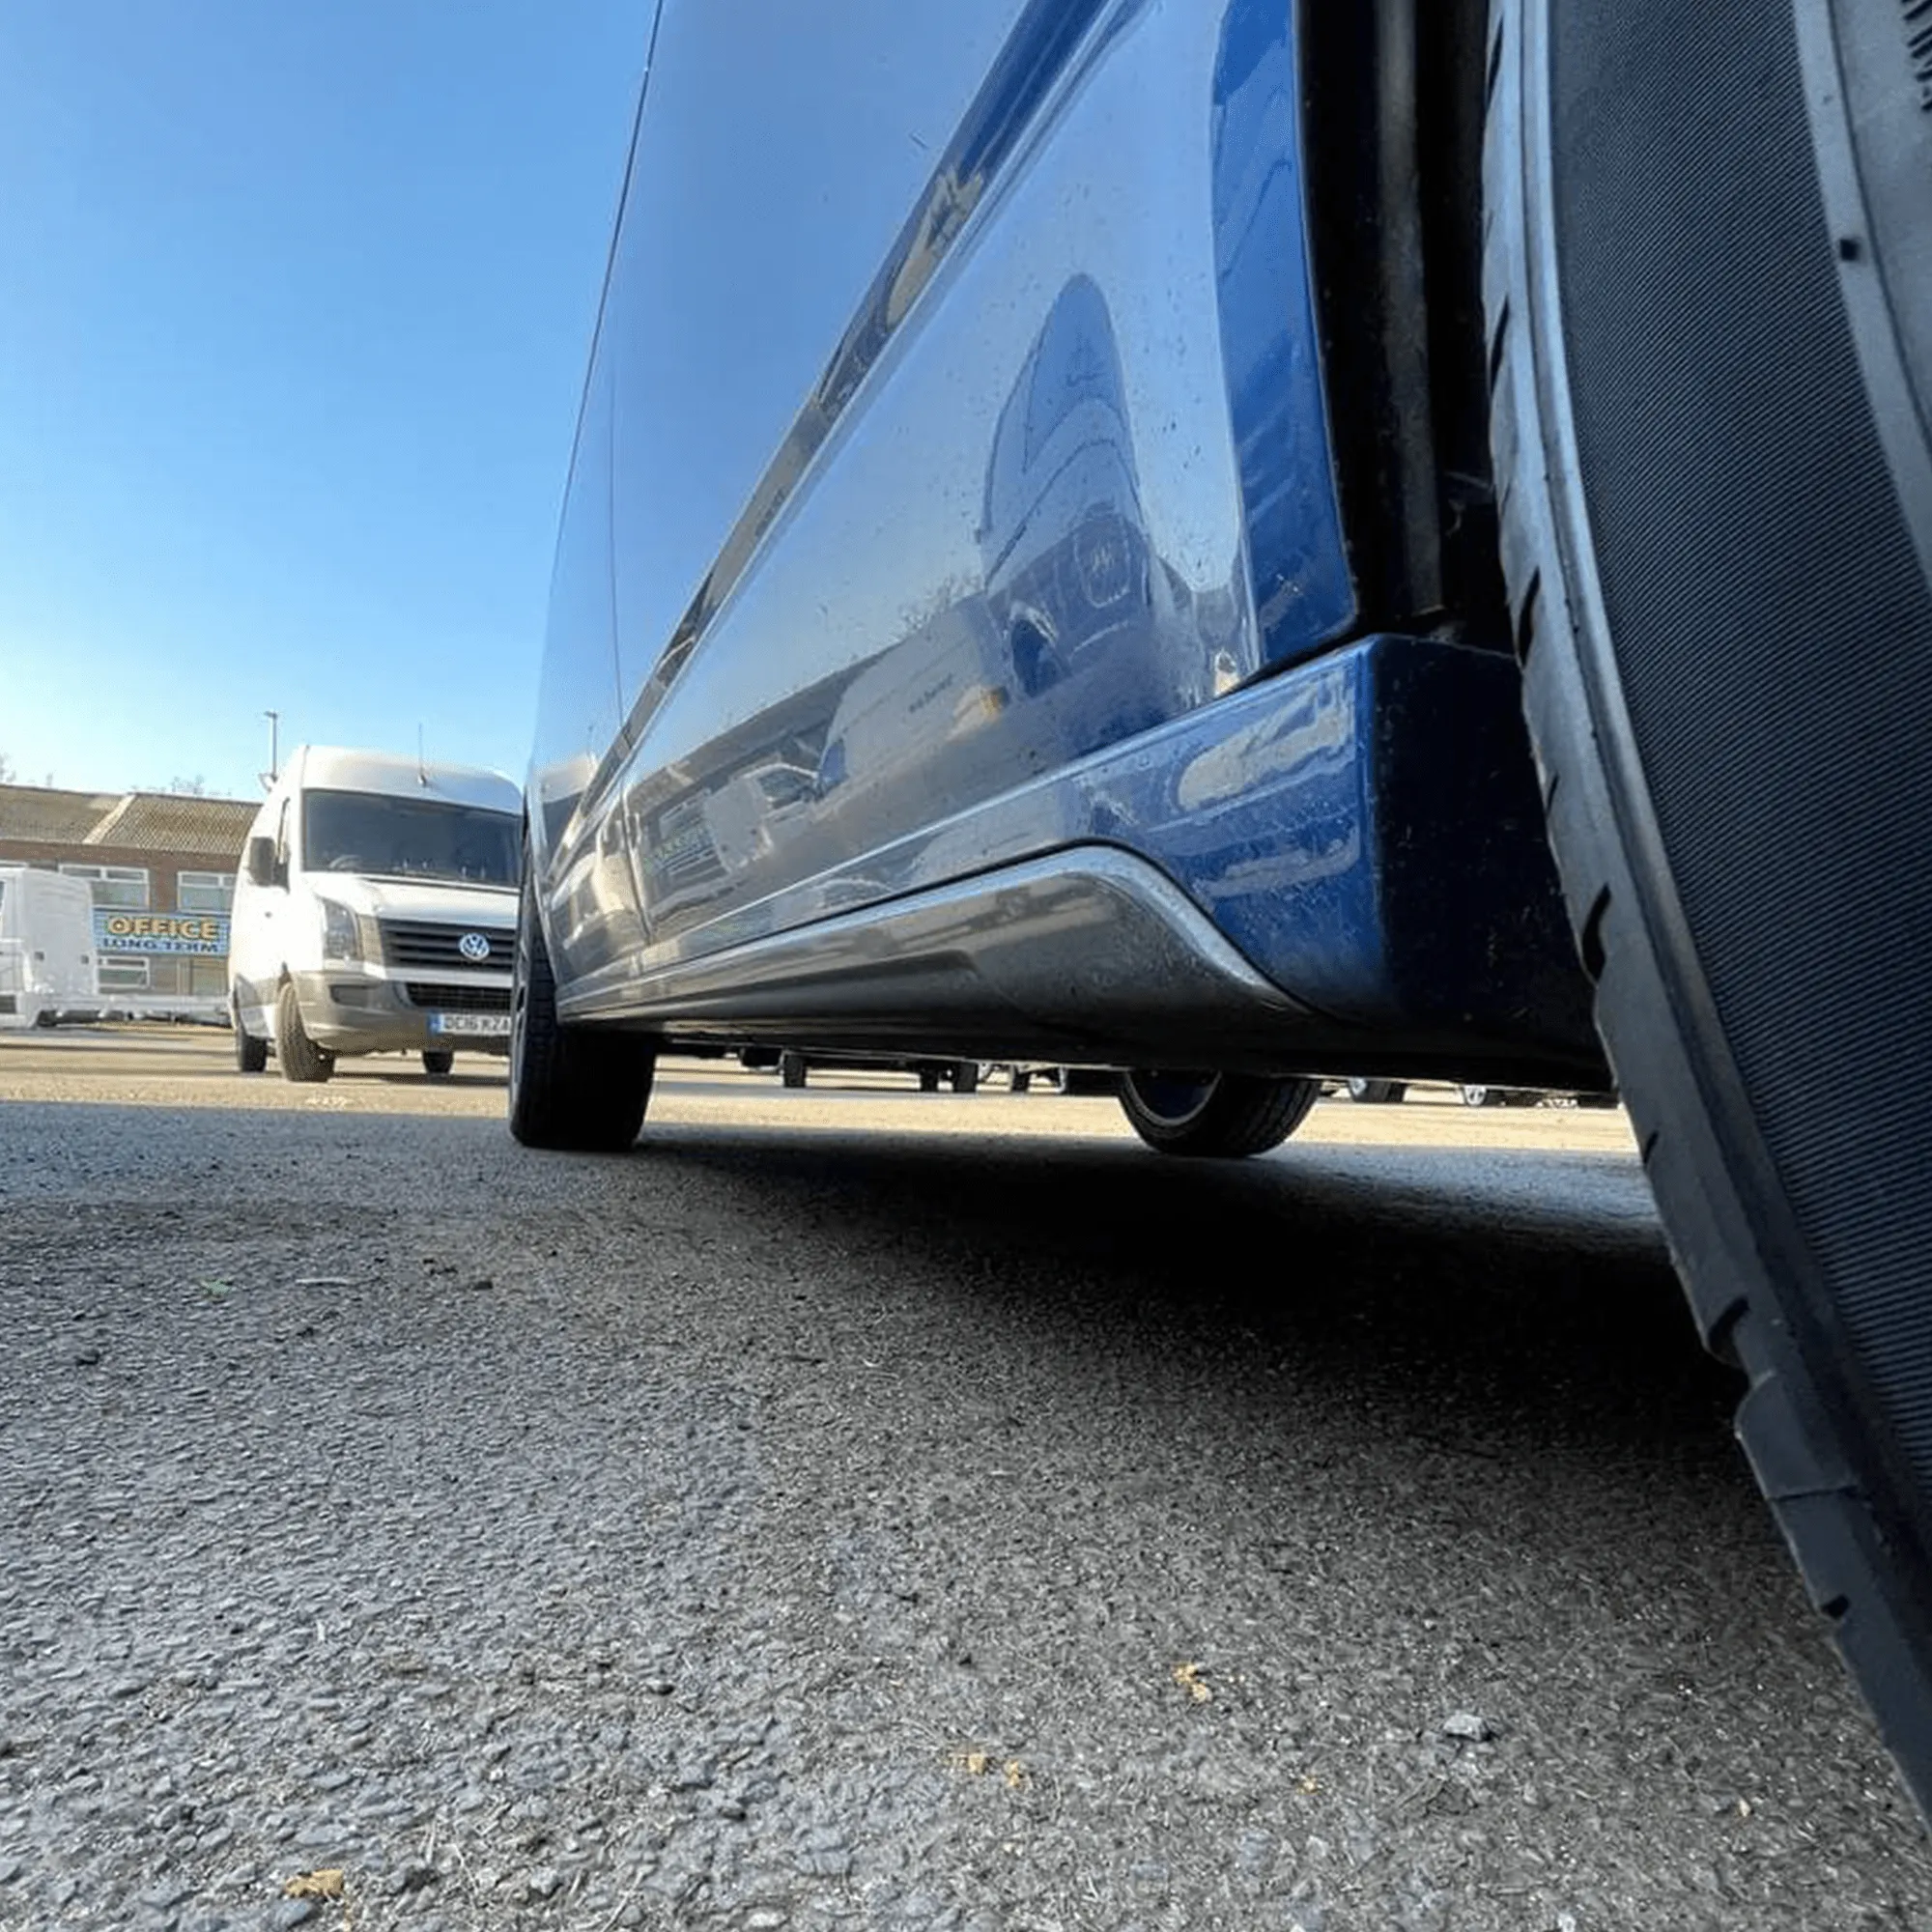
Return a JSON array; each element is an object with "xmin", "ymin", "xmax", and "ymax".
[{"xmin": 560, "ymin": 636, "xmax": 1594, "ymax": 1072}]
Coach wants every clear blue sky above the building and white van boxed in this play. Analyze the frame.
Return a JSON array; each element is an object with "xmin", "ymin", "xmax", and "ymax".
[{"xmin": 0, "ymin": 0, "xmax": 651, "ymax": 798}]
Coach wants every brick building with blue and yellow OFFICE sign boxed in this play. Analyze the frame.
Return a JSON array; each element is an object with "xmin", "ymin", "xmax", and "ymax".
[{"xmin": 0, "ymin": 784, "xmax": 255, "ymax": 1014}]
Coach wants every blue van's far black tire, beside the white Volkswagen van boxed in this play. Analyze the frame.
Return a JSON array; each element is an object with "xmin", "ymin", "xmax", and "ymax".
[{"xmin": 510, "ymin": 848, "xmax": 657, "ymax": 1153}]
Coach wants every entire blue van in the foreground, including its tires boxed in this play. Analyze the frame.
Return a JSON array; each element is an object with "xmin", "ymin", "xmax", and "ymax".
[{"xmin": 510, "ymin": 0, "xmax": 1932, "ymax": 1799}]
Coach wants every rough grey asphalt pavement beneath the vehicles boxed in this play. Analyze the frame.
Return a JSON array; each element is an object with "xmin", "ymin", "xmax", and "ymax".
[{"xmin": 0, "ymin": 1030, "xmax": 1932, "ymax": 1932}]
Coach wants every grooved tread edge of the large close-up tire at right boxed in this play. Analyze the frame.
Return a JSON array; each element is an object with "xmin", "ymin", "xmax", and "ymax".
[{"xmin": 1482, "ymin": 0, "xmax": 1932, "ymax": 1810}]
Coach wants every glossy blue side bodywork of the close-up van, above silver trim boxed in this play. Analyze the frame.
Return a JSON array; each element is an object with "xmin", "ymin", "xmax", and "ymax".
[{"xmin": 531, "ymin": 0, "xmax": 1596, "ymax": 1063}]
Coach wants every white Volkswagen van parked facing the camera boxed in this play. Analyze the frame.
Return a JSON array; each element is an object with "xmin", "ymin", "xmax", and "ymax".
[{"xmin": 228, "ymin": 746, "xmax": 524, "ymax": 1080}]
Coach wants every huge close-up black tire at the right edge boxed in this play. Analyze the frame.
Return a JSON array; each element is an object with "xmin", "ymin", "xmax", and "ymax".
[{"xmin": 1484, "ymin": 0, "xmax": 1932, "ymax": 1810}]
